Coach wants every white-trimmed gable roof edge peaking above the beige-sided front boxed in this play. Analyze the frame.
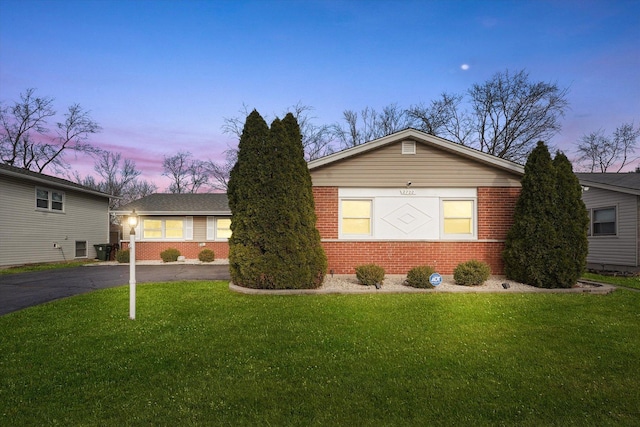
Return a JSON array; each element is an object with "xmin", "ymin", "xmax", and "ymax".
[{"xmin": 308, "ymin": 128, "xmax": 524, "ymax": 176}]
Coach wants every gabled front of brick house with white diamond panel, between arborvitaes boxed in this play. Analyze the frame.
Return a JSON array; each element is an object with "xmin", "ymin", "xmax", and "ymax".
[{"xmin": 309, "ymin": 129, "xmax": 524, "ymax": 274}]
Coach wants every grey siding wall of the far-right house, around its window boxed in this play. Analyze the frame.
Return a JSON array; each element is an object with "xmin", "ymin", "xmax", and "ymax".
[{"xmin": 582, "ymin": 187, "xmax": 639, "ymax": 267}]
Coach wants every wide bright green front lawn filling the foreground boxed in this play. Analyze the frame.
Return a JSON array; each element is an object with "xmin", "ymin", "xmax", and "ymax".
[{"xmin": 0, "ymin": 282, "xmax": 640, "ymax": 426}]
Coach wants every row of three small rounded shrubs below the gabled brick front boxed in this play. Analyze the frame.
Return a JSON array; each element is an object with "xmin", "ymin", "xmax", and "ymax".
[{"xmin": 355, "ymin": 260, "xmax": 491, "ymax": 289}]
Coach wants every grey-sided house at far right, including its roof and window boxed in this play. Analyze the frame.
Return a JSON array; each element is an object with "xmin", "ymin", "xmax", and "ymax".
[{"xmin": 576, "ymin": 173, "xmax": 640, "ymax": 271}]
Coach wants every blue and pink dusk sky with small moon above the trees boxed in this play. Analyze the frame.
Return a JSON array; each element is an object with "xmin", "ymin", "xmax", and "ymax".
[{"xmin": 0, "ymin": 0, "xmax": 640, "ymax": 191}]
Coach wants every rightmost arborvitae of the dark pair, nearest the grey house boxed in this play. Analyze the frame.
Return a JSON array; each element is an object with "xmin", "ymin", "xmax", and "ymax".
[{"xmin": 552, "ymin": 152, "xmax": 589, "ymax": 288}]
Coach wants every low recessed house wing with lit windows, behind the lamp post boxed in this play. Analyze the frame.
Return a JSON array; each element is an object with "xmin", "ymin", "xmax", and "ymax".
[{"xmin": 112, "ymin": 193, "xmax": 231, "ymax": 260}]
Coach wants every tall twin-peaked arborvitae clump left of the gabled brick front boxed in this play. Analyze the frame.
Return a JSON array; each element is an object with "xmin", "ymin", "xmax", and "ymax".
[{"xmin": 228, "ymin": 111, "xmax": 327, "ymax": 289}]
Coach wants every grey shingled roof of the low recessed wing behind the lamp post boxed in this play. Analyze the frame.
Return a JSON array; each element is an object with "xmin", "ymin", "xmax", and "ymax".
[{"xmin": 111, "ymin": 193, "xmax": 231, "ymax": 215}]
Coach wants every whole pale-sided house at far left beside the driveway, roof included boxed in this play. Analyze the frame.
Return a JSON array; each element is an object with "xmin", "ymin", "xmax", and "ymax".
[{"xmin": 0, "ymin": 164, "xmax": 109, "ymax": 266}]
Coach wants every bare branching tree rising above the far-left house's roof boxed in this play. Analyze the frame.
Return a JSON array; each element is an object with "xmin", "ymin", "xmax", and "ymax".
[{"xmin": 0, "ymin": 89, "xmax": 101, "ymax": 172}]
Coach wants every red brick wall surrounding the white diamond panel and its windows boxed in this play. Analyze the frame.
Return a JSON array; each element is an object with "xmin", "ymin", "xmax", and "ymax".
[{"xmin": 313, "ymin": 187, "xmax": 520, "ymax": 274}]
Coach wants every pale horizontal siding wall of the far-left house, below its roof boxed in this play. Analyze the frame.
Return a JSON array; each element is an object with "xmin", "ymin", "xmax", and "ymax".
[{"xmin": 0, "ymin": 176, "xmax": 109, "ymax": 265}]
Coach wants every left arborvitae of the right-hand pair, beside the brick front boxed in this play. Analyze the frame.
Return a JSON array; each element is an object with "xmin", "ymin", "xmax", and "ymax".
[{"xmin": 503, "ymin": 141, "xmax": 557, "ymax": 288}]
